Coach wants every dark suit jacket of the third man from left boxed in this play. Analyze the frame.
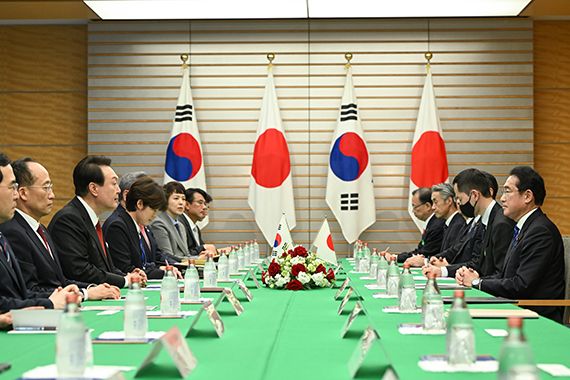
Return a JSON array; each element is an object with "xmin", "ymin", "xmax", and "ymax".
[{"xmin": 48, "ymin": 197, "xmax": 125, "ymax": 288}]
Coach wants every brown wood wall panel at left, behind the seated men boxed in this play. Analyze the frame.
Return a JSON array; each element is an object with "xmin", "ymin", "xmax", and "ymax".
[{"xmin": 0, "ymin": 25, "xmax": 87, "ymax": 223}]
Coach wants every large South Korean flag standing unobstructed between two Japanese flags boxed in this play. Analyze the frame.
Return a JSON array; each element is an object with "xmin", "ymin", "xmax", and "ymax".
[{"xmin": 326, "ymin": 67, "xmax": 376, "ymax": 243}]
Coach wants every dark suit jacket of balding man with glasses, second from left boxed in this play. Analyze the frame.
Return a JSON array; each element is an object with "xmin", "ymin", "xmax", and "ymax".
[{"xmin": 0, "ymin": 212, "xmax": 89, "ymax": 292}]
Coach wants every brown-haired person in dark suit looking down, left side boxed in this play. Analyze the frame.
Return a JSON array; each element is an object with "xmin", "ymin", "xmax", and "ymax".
[{"xmin": 105, "ymin": 176, "xmax": 181, "ymax": 279}]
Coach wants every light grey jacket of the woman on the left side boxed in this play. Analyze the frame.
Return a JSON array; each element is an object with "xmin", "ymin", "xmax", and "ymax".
[{"xmin": 150, "ymin": 211, "xmax": 190, "ymax": 262}]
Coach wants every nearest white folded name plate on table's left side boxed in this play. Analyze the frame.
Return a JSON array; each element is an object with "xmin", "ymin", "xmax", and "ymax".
[{"xmin": 135, "ymin": 326, "xmax": 198, "ymax": 378}]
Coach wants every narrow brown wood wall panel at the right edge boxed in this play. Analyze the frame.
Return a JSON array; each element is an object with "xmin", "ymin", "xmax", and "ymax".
[{"xmin": 534, "ymin": 20, "xmax": 570, "ymax": 235}]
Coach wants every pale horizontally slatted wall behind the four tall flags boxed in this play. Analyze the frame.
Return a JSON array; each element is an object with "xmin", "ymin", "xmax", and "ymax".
[{"xmin": 88, "ymin": 18, "xmax": 533, "ymax": 253}]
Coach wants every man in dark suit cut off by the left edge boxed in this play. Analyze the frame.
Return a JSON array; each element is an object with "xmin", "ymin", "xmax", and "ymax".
[{"xmin": 0, "ymin": 153, "xmax": 70, "ymax": 314}]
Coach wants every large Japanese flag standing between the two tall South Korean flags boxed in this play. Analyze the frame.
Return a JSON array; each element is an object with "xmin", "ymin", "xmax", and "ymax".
[{"xmin": 248, "ymin": 71, "xmax": 297, "ymax": 246}]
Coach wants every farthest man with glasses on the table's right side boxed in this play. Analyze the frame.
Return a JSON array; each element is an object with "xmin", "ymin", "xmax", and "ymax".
[{"xmin": 392, "ymin": 187, "xmax": 445, "ymax": 265}]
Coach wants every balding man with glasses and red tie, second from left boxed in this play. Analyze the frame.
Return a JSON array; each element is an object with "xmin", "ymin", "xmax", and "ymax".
[{"xmin": 0, "ymin": 158, "xmax": 121, "ymax": 300}]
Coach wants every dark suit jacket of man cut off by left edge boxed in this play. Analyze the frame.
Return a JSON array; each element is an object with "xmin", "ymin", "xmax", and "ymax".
[{"xmin": 0, "ymin": 233, "xmax": 53, "ymax": 313}]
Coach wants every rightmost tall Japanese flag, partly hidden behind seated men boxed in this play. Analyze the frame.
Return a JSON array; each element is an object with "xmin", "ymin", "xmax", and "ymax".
[{"xmin": 408, "ymin": 65, "xmax": 449, "ymax": 231}]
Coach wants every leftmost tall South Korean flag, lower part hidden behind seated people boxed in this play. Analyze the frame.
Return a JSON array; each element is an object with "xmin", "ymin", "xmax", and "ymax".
[{"xmin": 164, "ymin": 65, "xmax": 208, "ymax": 228}]
